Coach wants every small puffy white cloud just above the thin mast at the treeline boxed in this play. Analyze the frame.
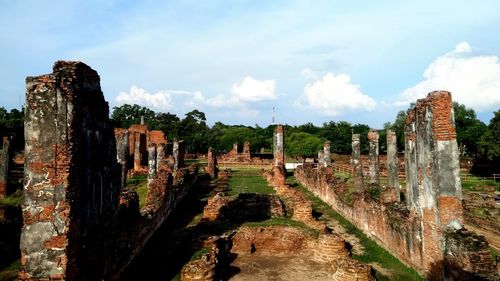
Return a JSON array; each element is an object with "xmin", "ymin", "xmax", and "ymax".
[{"xmin": 207, "ymin": 76, "xmax": 277, "ymax": 107}]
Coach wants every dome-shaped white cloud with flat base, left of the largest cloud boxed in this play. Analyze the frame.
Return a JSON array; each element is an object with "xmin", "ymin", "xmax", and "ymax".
[{"xmin": 295, "ymin": 73, "xmax": 376, "ymax": 116}]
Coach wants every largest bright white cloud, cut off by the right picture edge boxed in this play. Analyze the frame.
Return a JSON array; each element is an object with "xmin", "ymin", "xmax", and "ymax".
[{"xmin": 396, "ymin": 42, "xmax": 500, "ymax": 111}]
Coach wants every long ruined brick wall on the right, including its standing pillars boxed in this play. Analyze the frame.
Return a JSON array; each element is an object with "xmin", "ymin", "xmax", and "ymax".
[{"xmin": 295, "ymin": 91, "xmax": 498, "ymax": 280}]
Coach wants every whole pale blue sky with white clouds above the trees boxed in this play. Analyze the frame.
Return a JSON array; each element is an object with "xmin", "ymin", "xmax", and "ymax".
[{"xmin": 0, "ymin": 0, "xmax": 500, "ymax": 128}]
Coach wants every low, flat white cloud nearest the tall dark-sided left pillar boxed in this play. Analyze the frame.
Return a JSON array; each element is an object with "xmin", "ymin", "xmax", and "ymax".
[{"xmin": 116, "ymin": 86, "xmax": 205, "ymax": 111}]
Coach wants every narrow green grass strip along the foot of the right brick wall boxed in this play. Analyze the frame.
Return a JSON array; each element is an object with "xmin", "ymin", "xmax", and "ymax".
[{"xmin": 289, "ymin": 178, "xmax": 424, "ymax": 281}]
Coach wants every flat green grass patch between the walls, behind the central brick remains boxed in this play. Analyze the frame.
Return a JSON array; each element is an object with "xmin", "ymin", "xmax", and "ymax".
[{"xmin": 228, "ymin": 168, "xmax": 275, "ymax": 196}]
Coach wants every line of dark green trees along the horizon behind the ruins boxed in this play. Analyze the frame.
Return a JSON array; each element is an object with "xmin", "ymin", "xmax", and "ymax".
[{"xmin": 0, "ymin": 102, "xmax": 500, "ymax": 166}]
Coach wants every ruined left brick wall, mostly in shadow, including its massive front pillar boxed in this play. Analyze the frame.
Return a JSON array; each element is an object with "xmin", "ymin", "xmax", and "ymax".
[{"xmin": 19, "ymin": 61, "xmax": 197, "ymax": 280}]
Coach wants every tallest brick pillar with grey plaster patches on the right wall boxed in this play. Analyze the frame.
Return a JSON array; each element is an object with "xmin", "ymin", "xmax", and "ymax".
[{"xmin": 405, "ymin": 91, "xmax": 463, "ymax": 271}]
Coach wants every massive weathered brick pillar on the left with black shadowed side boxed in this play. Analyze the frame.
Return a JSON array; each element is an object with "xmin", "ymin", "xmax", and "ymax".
[{"xmin": 19, "ymin": 61, "xmax": 120, "ymax": 280}]
